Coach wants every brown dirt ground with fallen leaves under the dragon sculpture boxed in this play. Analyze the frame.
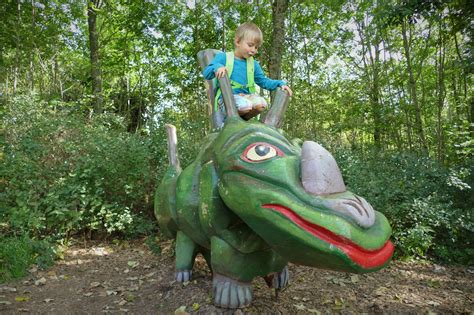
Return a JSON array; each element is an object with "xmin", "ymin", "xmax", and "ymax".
[{"xmin": 0, "ymin": 242, "xmax": 474, "ymax": 314}]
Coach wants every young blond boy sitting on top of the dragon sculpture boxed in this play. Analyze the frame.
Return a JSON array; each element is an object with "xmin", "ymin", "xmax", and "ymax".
[{"xmin": 203, "ymin": 22, "xmax": 293, "ymax": 119}]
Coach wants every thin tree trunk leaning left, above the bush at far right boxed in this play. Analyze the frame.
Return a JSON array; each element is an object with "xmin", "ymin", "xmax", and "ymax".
[{"xmin": 402, "ymin": 20, "xmax": 428, "ymax": 151}]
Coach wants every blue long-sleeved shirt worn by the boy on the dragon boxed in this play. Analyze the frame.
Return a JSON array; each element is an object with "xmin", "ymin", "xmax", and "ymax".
[{"xmin": 202, "ymin": 52, "xmax": 286, "ymax": 94}]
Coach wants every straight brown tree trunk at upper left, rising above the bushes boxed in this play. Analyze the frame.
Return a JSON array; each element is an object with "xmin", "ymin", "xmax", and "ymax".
[{"xmin": 87, "ymin": 0, "xmax": 103, "ymax": 114}]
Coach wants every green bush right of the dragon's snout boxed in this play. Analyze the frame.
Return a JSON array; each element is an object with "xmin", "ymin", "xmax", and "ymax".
[{"xmin": 335, "ymin": 149, "xmax": 474, "ymax": 262}]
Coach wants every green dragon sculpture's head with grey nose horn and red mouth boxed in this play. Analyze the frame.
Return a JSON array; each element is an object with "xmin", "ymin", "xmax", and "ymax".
[{"xmin": 214, "ymin": 116, "xmax": 394, "ymax": 273}]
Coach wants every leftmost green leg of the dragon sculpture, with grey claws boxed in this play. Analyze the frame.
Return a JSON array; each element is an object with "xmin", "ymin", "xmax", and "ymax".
[{"xmin": 176, "ymin": 231, "xmax": 197, "ymax": 282}]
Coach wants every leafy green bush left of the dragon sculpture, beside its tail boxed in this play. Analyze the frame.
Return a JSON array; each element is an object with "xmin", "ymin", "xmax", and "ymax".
[{"xmin": 0, "ymin": 96, "xmax": 160, "ymax": 240}]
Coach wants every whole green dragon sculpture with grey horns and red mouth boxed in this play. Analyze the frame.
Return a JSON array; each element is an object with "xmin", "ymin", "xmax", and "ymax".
[{"xmin": 155, "ymin": 50, "xmax": 393, "ymax": 308}]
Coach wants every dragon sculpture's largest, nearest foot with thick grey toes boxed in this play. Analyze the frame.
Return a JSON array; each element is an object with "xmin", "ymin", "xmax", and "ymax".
[{"xmin": 212, "ymin": 273, "xmax": 253, "ymax": 308}]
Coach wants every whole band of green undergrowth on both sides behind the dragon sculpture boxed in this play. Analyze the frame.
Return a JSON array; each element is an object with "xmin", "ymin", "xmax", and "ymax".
[{"xmin": 0, "ymin": 97, "xmax": 474, "ymax": 282}]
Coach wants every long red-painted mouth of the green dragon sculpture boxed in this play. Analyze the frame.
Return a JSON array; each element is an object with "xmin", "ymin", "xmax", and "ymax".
[{"xmin": 262, "ymin": 204, "xmax": 394, "ymax": 269}]
